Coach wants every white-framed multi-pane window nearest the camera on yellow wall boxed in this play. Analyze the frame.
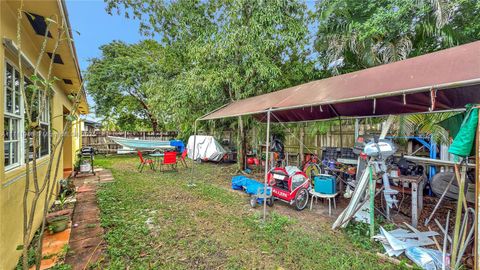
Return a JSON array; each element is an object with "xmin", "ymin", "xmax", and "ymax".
[{"xmin": 3, "ymin": 63, "xmax": 23, "ymax": 169}]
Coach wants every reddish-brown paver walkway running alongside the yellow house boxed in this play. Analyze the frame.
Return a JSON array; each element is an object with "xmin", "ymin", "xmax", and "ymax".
[{"xmin": 65, "ymin": 169, "xmax": 114, "ymax": 269}]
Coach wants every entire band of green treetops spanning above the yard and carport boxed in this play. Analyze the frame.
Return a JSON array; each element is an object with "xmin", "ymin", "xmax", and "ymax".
[{"xmin": 87, "ymin": 0, "xmax": 480, "ymax": 141}]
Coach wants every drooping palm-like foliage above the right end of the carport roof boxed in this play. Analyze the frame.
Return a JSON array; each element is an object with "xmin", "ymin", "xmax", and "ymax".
[{"xmin": 315, "ymin": 0, "xmax": 480, "ymax": 74}]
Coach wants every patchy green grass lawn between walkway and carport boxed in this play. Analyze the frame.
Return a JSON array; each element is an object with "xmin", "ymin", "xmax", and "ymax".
[{"xmin": 95, "ymin": 157, "xmax": 399, "ymax": 269}]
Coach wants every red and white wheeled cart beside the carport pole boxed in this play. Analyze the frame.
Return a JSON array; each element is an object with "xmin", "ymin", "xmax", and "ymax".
[{"xmin": 267, "ymin": 166, "xmax": 310, "ymax": 211}]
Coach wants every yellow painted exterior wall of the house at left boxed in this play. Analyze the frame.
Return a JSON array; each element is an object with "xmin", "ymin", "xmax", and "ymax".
[{"xmin": 0, "ymin": 1, "xmax": 81, "ymax": 270}]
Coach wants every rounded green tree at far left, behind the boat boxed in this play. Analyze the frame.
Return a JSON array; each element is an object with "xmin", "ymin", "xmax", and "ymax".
[{"xmin": 86, "ymin": 40, "xmax": 171, "ymax": 131}]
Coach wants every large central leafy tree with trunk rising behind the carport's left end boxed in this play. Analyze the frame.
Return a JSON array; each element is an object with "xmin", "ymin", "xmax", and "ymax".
[{"xmin": 106, "ymin": 0, "xmax": 317, "ymax": 168}]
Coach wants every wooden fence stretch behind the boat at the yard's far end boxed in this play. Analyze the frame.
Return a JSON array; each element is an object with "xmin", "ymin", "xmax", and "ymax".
[{"xmin": 82, "ymin": 131, "xmax": 177, "ymax": 154}]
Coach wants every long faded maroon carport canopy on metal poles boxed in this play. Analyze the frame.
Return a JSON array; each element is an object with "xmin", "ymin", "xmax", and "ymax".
[{"xmin": 199, "ymin": 41, "xmax": 480, "ymax": 122}]
